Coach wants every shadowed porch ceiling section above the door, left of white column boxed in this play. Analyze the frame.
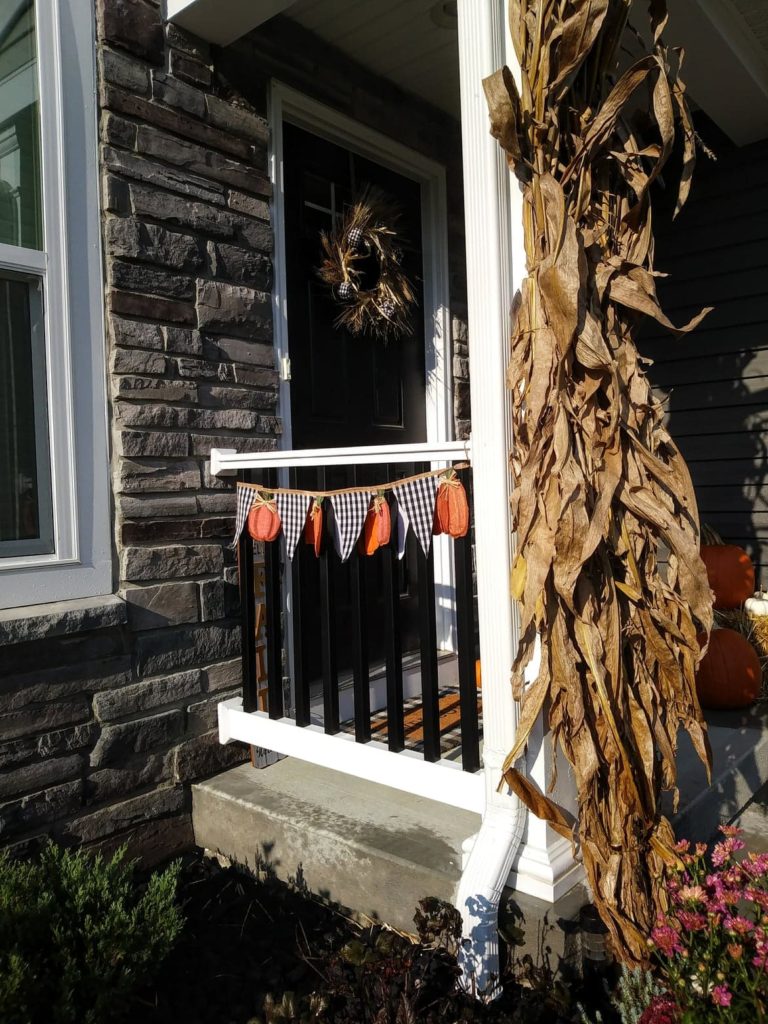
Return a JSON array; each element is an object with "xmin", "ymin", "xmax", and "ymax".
[{"xmin": 286, "ymin": 0, "xmax": 460, "ymax": 119}]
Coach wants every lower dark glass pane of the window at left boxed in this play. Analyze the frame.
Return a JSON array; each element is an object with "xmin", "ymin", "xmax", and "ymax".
[{"xmin": 0, "ymin": 273, "xmax": 53, "ymax": 557}]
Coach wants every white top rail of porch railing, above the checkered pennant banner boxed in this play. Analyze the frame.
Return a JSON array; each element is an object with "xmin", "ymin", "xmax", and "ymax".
[{"xmin": 211, "ymin": 440, "xmax": 472, "ymax": 476}]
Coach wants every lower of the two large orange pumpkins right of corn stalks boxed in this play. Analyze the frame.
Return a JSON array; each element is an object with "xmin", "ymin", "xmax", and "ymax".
[{"xmin": 696, "ymin": 629, "xmax": 762, "ymax": 709}]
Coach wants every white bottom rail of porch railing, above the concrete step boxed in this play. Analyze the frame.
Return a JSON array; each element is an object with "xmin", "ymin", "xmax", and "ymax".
[{"xmin": 218, "ymin": 697, "xmax": 485, "ymax": 814}]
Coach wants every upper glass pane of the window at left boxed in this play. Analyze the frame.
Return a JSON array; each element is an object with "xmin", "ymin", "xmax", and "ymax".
[{"xmin": 0, "ymin": 0, "xmax": 41, "ymax": 249}]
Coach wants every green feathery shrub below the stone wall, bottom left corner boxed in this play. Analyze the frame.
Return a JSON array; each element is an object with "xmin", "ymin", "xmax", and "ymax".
[{"xmin": 0, "ymin": 843, "xmax": 183, "ymax": 1024}]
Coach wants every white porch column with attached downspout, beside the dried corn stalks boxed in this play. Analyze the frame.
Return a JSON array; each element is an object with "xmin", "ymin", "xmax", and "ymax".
[{"xmin": 458, "ymin": 0, "xmax": 579, "ymax": 942}]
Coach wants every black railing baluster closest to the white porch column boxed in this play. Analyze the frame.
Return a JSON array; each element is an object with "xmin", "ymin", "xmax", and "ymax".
[{"xmin": 453, "ymin": 470, "xmax": 480, "ymax": 771}]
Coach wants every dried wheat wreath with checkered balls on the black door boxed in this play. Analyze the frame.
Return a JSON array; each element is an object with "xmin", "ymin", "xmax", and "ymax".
[{"xmin": 317, "ymin": 189, "xmax": 416, "ymax": 339}]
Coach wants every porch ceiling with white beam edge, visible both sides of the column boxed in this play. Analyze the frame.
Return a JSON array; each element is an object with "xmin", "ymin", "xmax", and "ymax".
[{"xmin": 167, "ymin": 0, "xmax": 768, "ymax": 145}]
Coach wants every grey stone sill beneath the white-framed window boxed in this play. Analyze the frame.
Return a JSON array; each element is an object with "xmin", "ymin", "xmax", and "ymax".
[{"xmin": 0, "ymin": 595, "xmax": 128, "ymax": 647}]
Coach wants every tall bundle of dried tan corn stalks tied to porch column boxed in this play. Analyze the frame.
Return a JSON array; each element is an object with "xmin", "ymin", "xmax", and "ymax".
[{"xmin": 485, "ymin": 0, "xmax": 712, "ymax": 962}]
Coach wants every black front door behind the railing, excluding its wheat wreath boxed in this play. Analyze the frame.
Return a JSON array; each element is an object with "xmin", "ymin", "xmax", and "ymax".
[{"xmin": 284, "ymin": 124, "xmax": 426, "ymax": 692}]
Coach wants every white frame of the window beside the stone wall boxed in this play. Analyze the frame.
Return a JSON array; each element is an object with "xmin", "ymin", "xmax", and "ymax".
[{"xmin": 0, "ymin": 0, "xmax": 113, "ymax": 609}]
